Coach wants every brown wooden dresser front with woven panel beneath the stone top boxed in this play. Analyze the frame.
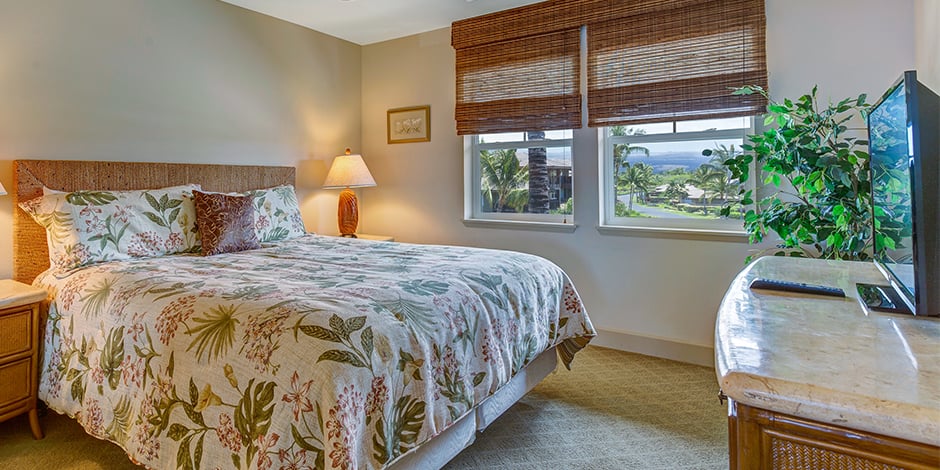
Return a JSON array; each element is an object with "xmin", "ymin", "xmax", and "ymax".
[{"xmin": 728, "ymin": 400, "xmax": 940, "ymax": 470}]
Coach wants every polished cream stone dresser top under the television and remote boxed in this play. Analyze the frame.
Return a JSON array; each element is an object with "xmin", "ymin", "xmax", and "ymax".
[{"xmin": 715, "ymin": 257, "xmax": 940, "ymax": 445}]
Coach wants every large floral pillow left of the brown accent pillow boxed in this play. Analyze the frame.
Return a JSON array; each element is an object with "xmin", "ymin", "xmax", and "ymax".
[{"xmin": 20, "ymin": 185, "xmax": 200, "ymax": 269}]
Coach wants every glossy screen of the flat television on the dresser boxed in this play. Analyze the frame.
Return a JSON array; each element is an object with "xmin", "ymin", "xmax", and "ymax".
[{"xmin": 868, "ymin": 77, "xmax": 915, "ymax": 298}]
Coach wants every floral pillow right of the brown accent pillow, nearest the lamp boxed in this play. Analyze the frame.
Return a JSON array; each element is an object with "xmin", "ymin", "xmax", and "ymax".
[{"xmin": 245, "ymin": 185, "xmax": 307, "ymax": 243}]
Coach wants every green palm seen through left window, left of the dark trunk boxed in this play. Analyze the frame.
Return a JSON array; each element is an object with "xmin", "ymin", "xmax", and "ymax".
[{"xmin": 480, "ymin": 149, "xmax": 529, "ymax": 212}]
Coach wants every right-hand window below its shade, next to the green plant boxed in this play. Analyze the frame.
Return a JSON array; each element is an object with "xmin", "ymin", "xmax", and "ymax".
[{"xmin": 601, "ymin": 117, "xmax": 753, "ymax": 232}]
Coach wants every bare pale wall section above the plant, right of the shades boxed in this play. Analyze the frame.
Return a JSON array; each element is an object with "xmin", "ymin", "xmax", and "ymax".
[{"xmin": 765, "ymin": 0, "xmax": 916, "ymax": 102}]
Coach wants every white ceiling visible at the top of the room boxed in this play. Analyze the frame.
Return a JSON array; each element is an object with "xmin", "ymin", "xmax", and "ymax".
[{"xmin": 221, "ymin": 0, "xmax": 541, "ymax": 45}]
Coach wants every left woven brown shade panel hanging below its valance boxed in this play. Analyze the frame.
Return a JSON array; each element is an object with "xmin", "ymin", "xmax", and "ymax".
[{"xmin": 455, "ymin": 29, "xmax": 581, "ymax": 135}]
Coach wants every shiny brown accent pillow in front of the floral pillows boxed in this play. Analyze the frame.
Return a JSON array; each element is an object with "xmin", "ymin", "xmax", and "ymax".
[{"xmin": 193, "ymin": 191, "xmax": 261, "ymax": 256}]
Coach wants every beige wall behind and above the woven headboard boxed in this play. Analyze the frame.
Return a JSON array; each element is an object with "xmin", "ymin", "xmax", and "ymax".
[{"xmin": 0, "ymin": 0, "xmax": 361, "ymax": 278}]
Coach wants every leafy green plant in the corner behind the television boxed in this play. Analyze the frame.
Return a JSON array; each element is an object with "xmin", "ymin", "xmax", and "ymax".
[{"xmin": 722, "ymin": 86, "xmax": 896, "ymax": 260}]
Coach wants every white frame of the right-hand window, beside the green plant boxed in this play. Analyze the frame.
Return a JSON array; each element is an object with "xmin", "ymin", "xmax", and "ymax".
[{"xmin": 597, "ymin": 116, "xmax": 760, "ymax": 235}]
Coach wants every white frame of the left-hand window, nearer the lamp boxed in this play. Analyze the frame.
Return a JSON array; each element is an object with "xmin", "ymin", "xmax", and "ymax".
[{"xmin": 464, "ymin": 129, "xmax": 577, "ymax": 231}]
